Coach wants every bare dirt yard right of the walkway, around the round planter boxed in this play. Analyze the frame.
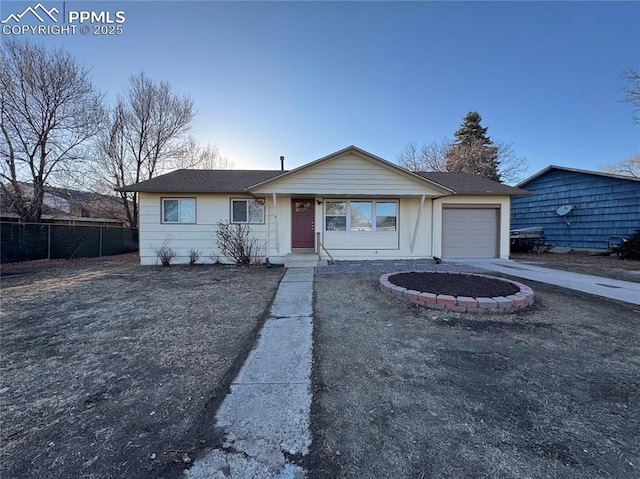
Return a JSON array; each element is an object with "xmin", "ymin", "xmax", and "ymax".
[{"xmin": 308, "ymin": 273, "xmax": 640, "ymax": 479}]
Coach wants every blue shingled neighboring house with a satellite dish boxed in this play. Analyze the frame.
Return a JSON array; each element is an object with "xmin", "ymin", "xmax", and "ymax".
[{"xmin": 511, "ymin": 165, "xmax": 640, "ymax": 248}]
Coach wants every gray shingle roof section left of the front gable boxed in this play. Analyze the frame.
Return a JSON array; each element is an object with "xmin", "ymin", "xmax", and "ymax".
[{"xmin": 120, "ymin": 170, "xmax": 286, "ymax": 193}]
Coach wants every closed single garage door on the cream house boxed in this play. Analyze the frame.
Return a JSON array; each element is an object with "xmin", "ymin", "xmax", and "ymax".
[{"xmin": 442, "ymin": 208, "xmax": 498, "ymax": 258}]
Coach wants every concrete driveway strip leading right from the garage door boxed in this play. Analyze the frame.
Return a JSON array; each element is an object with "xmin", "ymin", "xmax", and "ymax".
[{"xmin": 461, "ymin": 259, "xmax": 640, "ymax": 304}]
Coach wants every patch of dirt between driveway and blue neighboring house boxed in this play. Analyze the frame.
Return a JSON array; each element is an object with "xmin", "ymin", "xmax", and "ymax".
[{"xmin": 510, "ymin": 251, "xmax": 640, "ymax": 283}]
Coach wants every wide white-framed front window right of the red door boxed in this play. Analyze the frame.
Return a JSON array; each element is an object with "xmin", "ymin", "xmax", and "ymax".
[{"xmin": 325, "ymin": 200, "xmax": 398, "ymax": 232}]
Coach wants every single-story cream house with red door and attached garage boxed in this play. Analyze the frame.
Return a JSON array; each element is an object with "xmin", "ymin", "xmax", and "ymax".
[{"xmin": 123, "ymin": 146, "xmax": 527, "ymax": 264}]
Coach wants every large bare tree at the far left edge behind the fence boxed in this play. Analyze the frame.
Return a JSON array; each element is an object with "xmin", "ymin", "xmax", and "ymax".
[{"xmin": 0, "ymin": 40, "xmax": 104, "ymax": 222}]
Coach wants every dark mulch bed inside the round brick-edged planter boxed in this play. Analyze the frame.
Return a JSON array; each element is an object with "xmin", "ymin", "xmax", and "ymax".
[{"xmin": 389, "ymin": 272, "xmax": 520, "ymax": 298}]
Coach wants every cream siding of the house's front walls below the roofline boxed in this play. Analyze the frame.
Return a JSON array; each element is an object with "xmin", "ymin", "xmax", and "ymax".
[{"xmin": 140, "ymin": 193, "xmax": 509, "ymax": 264}]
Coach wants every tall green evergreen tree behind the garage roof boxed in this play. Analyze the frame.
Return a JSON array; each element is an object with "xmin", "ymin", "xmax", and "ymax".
[{"xmin": 445, "ymin": 111, "xmax": 500, "ymax": 181}]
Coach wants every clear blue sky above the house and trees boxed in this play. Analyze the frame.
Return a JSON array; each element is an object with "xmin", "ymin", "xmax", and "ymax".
[{"xmin": 0, "ymin": 1, "xmax": 640, "ymax": 178}]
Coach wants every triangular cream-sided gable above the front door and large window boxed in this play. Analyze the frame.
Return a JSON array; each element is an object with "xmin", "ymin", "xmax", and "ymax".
[{"xmin": 254, "ymin": 154, "xmax": 443, "ymax": 197}]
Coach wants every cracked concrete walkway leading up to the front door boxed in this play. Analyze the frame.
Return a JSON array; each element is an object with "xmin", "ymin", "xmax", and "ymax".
[{"xmin": 185, "ymin": 268, "xmax": 313, "ymax": 479}]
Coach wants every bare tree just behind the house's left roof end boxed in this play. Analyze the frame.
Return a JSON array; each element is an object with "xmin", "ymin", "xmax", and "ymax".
[{"xmin": 97, "ymin": 73, "xmax": 194, "ymax": 226}]
